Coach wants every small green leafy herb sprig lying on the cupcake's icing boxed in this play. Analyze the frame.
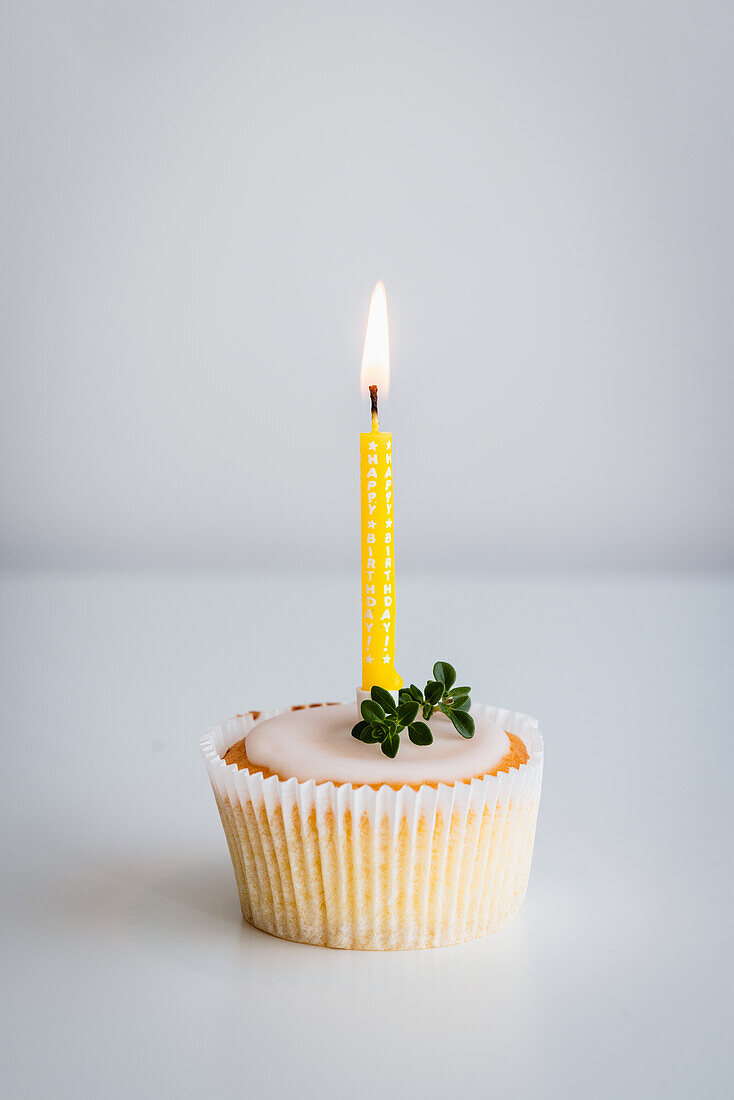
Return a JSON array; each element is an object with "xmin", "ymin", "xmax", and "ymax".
[{"xmin": 352, "ymin": 661, "xmax": 474, "ymax": 758}]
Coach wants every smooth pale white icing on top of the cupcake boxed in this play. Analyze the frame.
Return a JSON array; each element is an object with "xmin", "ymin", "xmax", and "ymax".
[{"xmin": 245, "ymin": 703, "xmax": 510, "ymax": 785}]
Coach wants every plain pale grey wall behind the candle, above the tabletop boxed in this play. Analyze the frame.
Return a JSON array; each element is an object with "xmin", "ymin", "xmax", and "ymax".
[{"xmin": 0, "ymin": 0, "xmax": 734, "ymax": 570}]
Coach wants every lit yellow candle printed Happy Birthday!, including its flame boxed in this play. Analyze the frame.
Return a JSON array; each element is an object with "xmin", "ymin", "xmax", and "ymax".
[{"xmin": 360, "ymin": 283, "xmax": 403, "ymax": 691}]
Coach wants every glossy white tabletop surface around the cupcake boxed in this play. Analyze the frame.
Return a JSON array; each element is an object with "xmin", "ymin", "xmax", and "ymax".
[{"xmin": 0, "ymin": 573, "xmax": 734, "ymax": 1100}]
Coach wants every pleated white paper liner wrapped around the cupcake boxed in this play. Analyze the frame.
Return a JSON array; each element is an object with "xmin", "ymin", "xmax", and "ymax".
[{"xmin": 200, "ymin": 706, "xmax": 543, "ymax": 950}]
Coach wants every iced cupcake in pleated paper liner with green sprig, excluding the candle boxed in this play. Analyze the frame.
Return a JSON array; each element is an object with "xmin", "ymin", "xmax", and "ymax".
[{"xmin": 201, "ymin": 666, "xmax": 543, "ymax": 950}]
